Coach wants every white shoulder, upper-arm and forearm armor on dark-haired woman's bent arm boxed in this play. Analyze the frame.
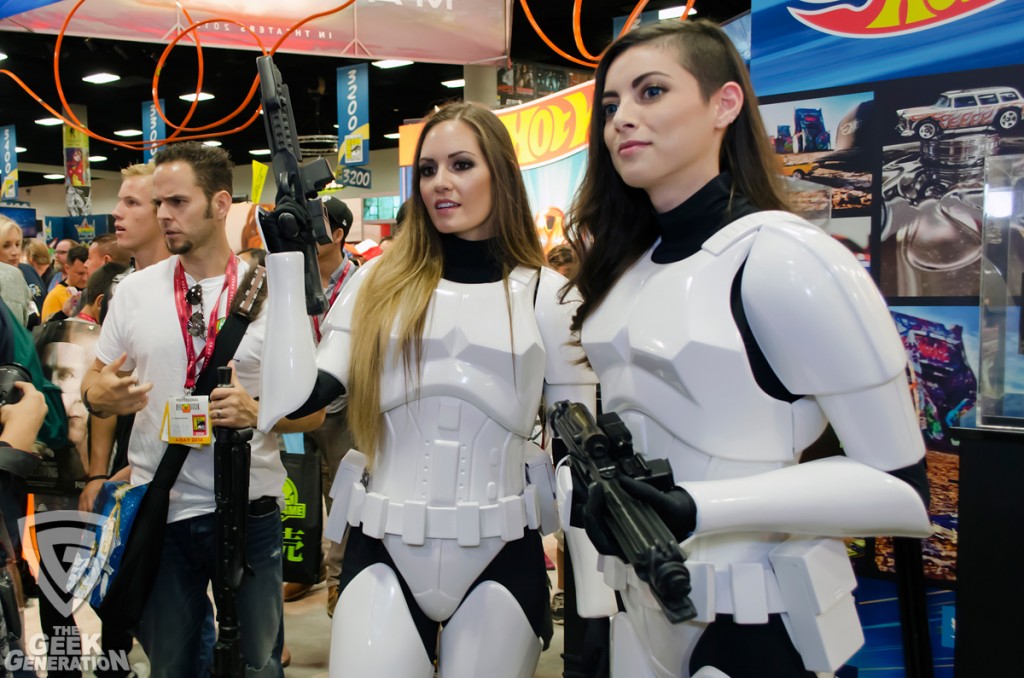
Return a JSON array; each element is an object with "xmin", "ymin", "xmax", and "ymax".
[{"xmin": 683, "ymin": 217, "xmax": 931, "ymax": 537}]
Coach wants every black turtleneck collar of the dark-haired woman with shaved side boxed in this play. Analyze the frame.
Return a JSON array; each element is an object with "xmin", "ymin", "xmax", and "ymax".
[{"xmin": 651, "ymin": 172, "xmax": 759, "ymax": 263}]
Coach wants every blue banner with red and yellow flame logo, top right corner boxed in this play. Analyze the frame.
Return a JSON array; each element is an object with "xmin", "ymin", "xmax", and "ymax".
[{"xmin": 751, "ymin": 0, "xmax": 1024, "ymax": 96}]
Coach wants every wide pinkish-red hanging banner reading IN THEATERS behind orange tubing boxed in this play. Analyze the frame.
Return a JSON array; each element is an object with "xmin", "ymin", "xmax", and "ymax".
[{"xmin": 0, "ymin": 0, "xmax": 512, "ymax": 63}]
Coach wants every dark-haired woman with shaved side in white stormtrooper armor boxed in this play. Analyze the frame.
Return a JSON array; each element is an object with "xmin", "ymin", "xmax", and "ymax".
[{"xmin": 559, "ymin": 20, "xmax": 930, "ymax": 678}]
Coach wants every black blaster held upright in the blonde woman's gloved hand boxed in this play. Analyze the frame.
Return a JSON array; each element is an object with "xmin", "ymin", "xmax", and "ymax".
[{"xmin": 256, "ymin": 56, "xmax": 334, "ymax": 315}]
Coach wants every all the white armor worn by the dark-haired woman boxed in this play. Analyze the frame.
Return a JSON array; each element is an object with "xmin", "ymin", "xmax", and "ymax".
[{"xmin": 583, "ymin": 212, "xmax": 929, "ymax": 677}]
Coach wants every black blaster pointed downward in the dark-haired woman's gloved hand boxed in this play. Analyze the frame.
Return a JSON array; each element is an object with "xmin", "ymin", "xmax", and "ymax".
[{"xmin": 548, "ymin": 400, "xmax": 696, "ymax": 624}]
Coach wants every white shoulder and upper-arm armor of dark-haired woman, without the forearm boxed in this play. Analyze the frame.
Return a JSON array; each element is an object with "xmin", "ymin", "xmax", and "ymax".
[{"xmin": 742, "ymin": 223, "xmax": 925, "ymax": 471}]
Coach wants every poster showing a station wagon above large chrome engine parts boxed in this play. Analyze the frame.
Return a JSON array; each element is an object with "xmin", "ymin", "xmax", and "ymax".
[{"xmin": 877, "ymin": 68, "xmax": 1024, "ymax": 303}]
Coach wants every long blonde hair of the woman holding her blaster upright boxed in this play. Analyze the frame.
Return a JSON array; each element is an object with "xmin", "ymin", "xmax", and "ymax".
[{"xmin": 348, "ymin": 101, "xmax": 544, "ymax": 465}]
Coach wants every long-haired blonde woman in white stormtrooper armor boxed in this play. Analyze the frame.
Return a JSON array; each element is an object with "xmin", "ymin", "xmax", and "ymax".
[{"xmin": 292, "ymin": 102, "xmax": 595, "ymax": 678}]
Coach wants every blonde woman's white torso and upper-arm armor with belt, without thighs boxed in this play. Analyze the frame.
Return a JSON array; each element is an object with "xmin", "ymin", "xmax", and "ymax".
[{"xmin": 317, "ymin": 264, "xmax": 594, "ymax": 621}]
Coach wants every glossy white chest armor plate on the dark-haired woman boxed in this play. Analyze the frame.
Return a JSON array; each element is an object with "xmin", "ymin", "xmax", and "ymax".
[{"xmin": 582, "ymin": 222, "xmax": 822, "ymax": 482}]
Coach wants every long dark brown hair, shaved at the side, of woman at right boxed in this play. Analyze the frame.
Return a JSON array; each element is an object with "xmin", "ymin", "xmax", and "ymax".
[{"xmin": 565, "ymin": 19, "xmax": 785, "ymax": 331}]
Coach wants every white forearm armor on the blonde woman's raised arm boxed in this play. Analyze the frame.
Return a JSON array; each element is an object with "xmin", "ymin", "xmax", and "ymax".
[{"xmin": 256, "ymin": 252, "xmax": 316, "ymax": 433}]
